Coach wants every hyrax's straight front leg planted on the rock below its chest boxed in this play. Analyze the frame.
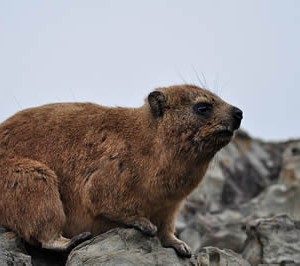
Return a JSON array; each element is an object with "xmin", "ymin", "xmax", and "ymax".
[{"xmin": 156, "ymin": 205, "xmax": 192, "ymax": 258}]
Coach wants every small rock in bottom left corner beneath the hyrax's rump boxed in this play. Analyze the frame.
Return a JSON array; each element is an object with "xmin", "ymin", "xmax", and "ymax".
[{"xmin": 0, "ymin": 231, "xmax": 32, "ymax": 266}]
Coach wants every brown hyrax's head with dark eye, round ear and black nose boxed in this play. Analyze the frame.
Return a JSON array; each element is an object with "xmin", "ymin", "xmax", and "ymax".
[{"xmin": 148, "ymin": 85, "xmax": 243, "ymax": 156}]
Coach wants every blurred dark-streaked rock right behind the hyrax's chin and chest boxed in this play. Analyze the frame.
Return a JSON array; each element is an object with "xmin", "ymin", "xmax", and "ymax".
[{"xmin": 188, "ymin": 131, "xmax": 287, "ymax": 214}]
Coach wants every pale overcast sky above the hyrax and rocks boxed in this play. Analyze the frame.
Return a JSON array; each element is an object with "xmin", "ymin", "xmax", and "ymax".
[{"xmin": 0, "ymin": 0, "xmax": 300, "ymax": 140}]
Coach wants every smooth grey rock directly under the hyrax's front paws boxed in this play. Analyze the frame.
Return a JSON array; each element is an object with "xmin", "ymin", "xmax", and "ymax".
[{"xmin": 67, "ymin": 228, "xmax": 190, "ymax": 266}]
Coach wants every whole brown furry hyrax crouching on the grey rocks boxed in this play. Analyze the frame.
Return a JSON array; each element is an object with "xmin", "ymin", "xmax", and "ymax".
[{"xmin": 0, "ymin": 85, "xmax": 242, "ymax": 257}]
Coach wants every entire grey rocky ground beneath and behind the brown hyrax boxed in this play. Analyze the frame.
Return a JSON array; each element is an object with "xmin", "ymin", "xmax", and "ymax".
[{"xmin": 0, "ymin": 131, "xmax": 300, "ymax": 266}]
